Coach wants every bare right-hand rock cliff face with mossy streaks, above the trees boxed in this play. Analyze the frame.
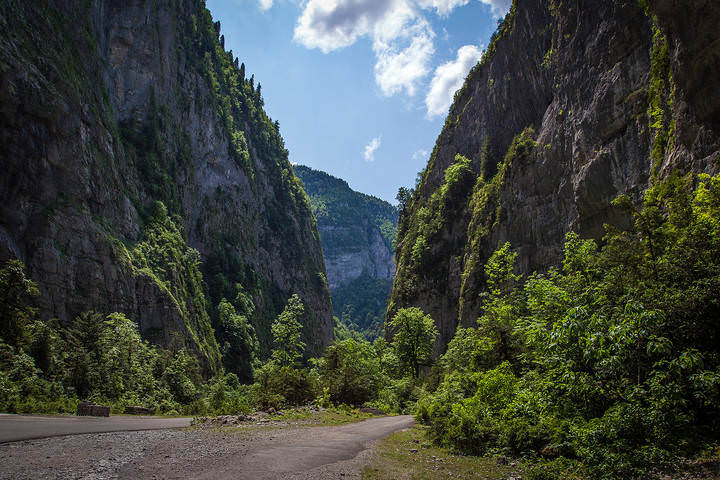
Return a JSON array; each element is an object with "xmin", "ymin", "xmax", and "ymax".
[{"xmin": 388, "ymin": 0, "xmax": 720, "ymax": 351}]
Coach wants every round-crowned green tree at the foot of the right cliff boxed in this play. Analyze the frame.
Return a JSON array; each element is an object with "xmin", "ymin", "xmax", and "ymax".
[{"xmin": 388, "ymin": 307, "xmax": 438, "ymax": 378}]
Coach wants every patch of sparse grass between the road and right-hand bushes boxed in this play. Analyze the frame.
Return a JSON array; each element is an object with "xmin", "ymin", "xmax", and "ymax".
[{"xmin": 362, "ymin": 427, "xmax": 523, "ymax": 480}]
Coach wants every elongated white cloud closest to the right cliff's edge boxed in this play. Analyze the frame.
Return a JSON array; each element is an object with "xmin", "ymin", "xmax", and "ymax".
[{"xmin": 425, "ymin": 45, "xmax": 482, "ymax": 117}]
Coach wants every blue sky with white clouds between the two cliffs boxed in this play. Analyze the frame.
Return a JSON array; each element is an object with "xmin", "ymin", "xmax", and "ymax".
[{"xmin": 207, "ymin": 0, "xmax": 510, "ymax": 203}]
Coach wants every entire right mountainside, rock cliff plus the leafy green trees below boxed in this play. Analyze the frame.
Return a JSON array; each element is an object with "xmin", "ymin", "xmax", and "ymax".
[{"xmin": 386, "ymin": 0, "xmax": 720, "ymax": 479}]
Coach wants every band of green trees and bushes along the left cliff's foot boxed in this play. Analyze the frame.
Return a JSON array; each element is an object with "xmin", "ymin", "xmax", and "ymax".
[{"xmin": 0, "ymin": 258, "xmax": 434, "ymax": 415}]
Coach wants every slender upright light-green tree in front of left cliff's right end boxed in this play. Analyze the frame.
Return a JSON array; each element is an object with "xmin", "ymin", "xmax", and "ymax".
[{"xmin": 272, "ymin": 294, "xmax": 305, "ymax": 367}]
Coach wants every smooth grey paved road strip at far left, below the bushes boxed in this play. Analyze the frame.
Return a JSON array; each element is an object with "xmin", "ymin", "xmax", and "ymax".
[{"xmin": 0, "ymin": 414, "xmax": 192, "ymax": 443}]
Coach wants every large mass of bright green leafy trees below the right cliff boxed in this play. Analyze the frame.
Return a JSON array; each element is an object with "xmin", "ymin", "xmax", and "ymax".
[{"xmin": 417, "ymin": 175, "xmax": 720, "ymax": 479}]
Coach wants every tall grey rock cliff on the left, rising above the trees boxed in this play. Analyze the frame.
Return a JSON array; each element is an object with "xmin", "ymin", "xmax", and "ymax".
[{"xmin": 0, "ymin": 0, "xmax": 332, "ymax": 368}]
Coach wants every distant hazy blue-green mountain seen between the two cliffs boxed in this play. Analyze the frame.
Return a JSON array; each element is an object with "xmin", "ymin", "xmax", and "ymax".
[{"xmin": 294, "ymin": 165, "xmax": 398, "ymax": 336}]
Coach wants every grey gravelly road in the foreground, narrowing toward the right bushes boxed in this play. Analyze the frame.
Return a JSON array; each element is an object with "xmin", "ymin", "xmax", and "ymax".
[{"xmin": 0, "ymin": 416, "xmax": 413, "ymax": 480}]
